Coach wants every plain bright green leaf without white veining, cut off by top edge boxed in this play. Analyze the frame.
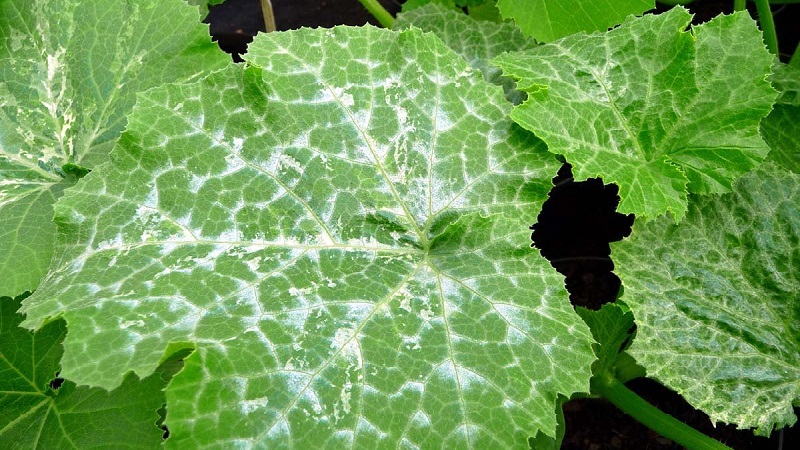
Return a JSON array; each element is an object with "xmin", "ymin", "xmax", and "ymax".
[{"xmin": 497, "ymin": 0, "xmax": 655, "ymax": 42}]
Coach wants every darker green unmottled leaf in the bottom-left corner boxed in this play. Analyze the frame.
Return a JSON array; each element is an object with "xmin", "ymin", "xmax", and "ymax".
[{"xmin": 0, "ymin": 297, "xmax": 166, "ymax": 450}]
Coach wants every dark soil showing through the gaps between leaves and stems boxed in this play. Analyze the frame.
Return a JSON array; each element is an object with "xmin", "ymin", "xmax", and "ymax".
[{"xmin": 207, "ymin": 0, "xmax": 800, "ymax": 450}]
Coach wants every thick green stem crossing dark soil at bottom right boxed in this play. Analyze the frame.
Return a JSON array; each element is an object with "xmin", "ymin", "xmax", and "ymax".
[{"xmin": 592, "ymin": 376, "xmax": 731, "ymax": 450}]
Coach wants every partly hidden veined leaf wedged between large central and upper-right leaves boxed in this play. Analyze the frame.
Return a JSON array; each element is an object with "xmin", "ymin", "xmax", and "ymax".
[{"xmin": 394, "ymin": 4, "xmax": 536, "ymax": 104}]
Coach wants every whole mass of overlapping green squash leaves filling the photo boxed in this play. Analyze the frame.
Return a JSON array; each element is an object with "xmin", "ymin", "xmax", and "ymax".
[{"xmin": 0, "ymin": 0, "xmax": 800, "ymax": 449}]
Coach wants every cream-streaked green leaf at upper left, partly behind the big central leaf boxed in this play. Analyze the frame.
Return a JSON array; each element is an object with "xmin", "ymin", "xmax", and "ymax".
[{"xmin": 0, "ymin": 0, "xmax": 228, "ymax": 295}]
